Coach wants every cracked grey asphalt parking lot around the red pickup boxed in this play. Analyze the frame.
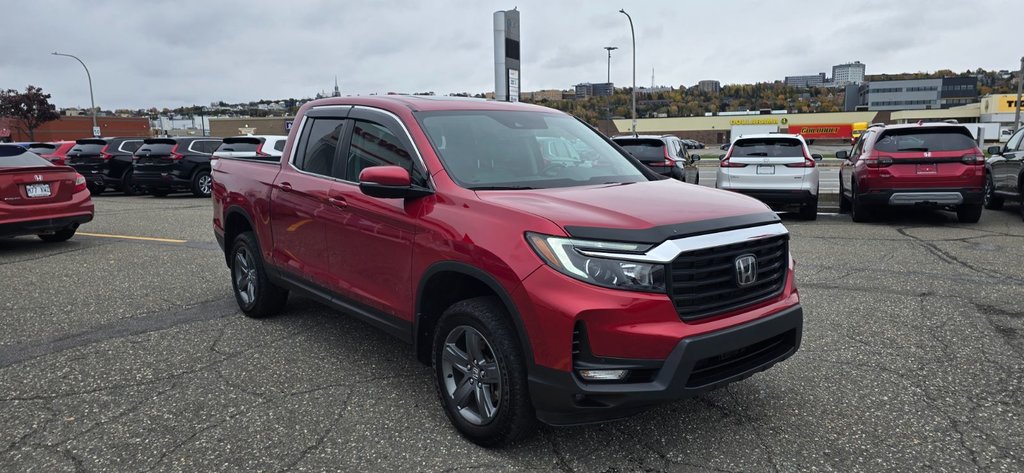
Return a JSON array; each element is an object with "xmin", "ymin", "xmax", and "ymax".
[{"xmin": 0, "ymin": 195, "xmax": 1024, "ymax": 472}]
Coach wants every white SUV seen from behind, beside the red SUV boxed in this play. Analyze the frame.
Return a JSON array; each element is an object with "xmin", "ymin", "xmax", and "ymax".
[{"xmin": 715, "ymin": 133, "xmax": 821, "ymax": 220}]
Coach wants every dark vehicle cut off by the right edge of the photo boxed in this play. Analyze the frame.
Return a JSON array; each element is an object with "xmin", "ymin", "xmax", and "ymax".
[{"xmin": 985, "ymin": 128, "xmax": 1024, "ymax": 217}]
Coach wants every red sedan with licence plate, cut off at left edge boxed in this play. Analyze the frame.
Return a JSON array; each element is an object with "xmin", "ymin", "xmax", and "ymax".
[{"xmin": 0, "ymin": 144, "xmax": 93, "ymax": 242}]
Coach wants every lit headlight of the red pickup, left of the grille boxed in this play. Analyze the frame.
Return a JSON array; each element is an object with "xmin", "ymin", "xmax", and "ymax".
[{"xmin": 526, "ymin": 233, "xmax": 665, "ymax": 293}]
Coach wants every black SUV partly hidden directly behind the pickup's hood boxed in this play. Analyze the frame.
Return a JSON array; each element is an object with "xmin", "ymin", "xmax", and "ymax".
[{"xmin": 611, "ymin": 135, "xmax": 700, "ymax": 184}]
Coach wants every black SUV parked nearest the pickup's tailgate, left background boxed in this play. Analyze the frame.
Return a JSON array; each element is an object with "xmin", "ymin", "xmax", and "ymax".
[{"xmin": 133, "ymin": 136, "xmax": 222, "ymax": 197}]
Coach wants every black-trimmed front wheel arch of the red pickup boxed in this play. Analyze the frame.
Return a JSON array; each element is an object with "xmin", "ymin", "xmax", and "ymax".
[{"xmin": 413, "ymin": 261, "xmax": 534, "ymax": 366}]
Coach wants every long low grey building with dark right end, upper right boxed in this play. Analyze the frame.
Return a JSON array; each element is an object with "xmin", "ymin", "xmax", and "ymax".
[{"xmin": 859, "ymin": 77, "xmax": 978, "ymax": 111}]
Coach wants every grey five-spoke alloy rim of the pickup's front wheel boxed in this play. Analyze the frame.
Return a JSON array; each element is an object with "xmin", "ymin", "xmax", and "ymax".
[{"xmin": 441, "ymin": 326, "xmax": 502, "ymax": 425}]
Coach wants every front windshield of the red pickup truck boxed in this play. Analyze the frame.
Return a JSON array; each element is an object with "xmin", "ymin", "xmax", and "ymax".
[{"xmin": 418, "ymin": 111, "xmax": 647, "ymax": 190}]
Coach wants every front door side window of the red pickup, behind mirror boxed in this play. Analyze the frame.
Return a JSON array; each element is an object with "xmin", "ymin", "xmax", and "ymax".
[{"xmin": 340, "ymin": 121, "xmax": 413, "ymax": 181}]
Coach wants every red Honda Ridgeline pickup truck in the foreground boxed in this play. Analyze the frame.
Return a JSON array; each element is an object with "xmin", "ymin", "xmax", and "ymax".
[{"xmin": 213, "ymin": 96, "xmax": 803, "ymax": 446}]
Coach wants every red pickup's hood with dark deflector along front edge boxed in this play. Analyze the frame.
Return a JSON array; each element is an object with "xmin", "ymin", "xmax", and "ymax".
[{"xmin": 476, "ymin": 179, "xmax": 779, "ymax": 243}]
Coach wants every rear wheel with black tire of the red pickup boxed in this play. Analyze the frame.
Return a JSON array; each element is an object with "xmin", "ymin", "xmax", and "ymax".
[{"xmin": 228, "ymin": 231, "xmax": 288, "ymax": 318}]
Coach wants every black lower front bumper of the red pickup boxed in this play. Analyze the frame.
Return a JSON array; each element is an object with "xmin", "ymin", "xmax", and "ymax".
[{"xmin": 529, "ymin": 304, "xmax": 803, "ymax": 425}]
